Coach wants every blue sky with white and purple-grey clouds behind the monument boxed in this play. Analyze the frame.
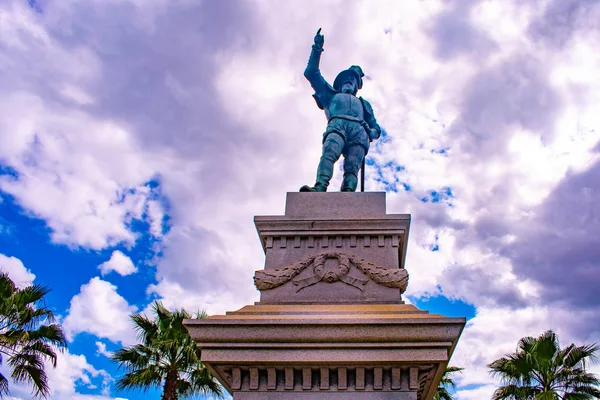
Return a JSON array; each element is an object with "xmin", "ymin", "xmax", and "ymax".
[{"xmin": 0, "ymin": 0, "xmax": 600, "ymax": 400}]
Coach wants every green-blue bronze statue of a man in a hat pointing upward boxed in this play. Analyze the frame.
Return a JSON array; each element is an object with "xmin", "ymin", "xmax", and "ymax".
[{"xmin": 300, "ymin": 29, "xmax": 381, "ymax": 192}]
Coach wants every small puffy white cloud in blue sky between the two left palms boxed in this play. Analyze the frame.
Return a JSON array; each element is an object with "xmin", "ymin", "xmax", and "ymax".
[{"xmin": 63, "ymin": 277, "xmax": 136, "ymax": 345}]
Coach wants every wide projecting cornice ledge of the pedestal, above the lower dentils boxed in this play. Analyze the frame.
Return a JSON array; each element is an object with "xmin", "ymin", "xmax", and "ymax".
[{"xmin": 185, "ymin": 303, "xmax": 466, "ymax": 347}]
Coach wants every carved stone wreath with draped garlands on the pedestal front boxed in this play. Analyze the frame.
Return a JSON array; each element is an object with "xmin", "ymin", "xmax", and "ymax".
[{"xmin": 254, "ymin": 251, "xmax": 408, "ymax": 293}]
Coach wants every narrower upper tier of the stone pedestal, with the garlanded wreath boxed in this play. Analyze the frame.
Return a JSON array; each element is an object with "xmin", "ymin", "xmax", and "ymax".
[{"xmin": 255, "ymin": 193, "xmax": 410, "ymax": 304}]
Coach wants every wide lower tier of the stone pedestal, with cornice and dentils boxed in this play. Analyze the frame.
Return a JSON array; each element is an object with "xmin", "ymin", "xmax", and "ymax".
[{"xmin": 186, "ymin": 304, "xmax": 465, "ymax": 400}]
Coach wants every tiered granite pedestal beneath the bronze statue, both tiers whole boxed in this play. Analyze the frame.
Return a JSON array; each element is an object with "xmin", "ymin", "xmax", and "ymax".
[{"xmin": 186, "ymin": 193, "xmax": 465, "ymax": 400}]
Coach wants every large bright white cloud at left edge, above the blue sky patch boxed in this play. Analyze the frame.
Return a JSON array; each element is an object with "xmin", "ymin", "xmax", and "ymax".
[{"xmin": 0, "ymin": 93, "xmax": 164, "ymax": 249}]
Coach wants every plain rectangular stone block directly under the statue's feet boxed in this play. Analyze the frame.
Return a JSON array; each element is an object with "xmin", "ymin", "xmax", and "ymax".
[{"xmin": 285, "ymin": 192, "xmax": 385, "ymax": 219}]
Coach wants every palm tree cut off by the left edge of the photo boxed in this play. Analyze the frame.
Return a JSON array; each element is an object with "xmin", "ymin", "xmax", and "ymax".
[{"xmin": 0, "ymin": 272, "xmax": 67, "ymax": 398}]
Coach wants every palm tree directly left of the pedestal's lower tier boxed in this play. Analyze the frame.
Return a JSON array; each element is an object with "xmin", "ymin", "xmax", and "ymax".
[{"xmin": 112, "ymin": 301, "xmax": 222, "ymax": 400}]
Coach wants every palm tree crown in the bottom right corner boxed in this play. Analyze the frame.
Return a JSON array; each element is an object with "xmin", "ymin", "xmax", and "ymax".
[{"xmin": 488, "ymin": 331, "xmax": 600, "ymax": 400}]
